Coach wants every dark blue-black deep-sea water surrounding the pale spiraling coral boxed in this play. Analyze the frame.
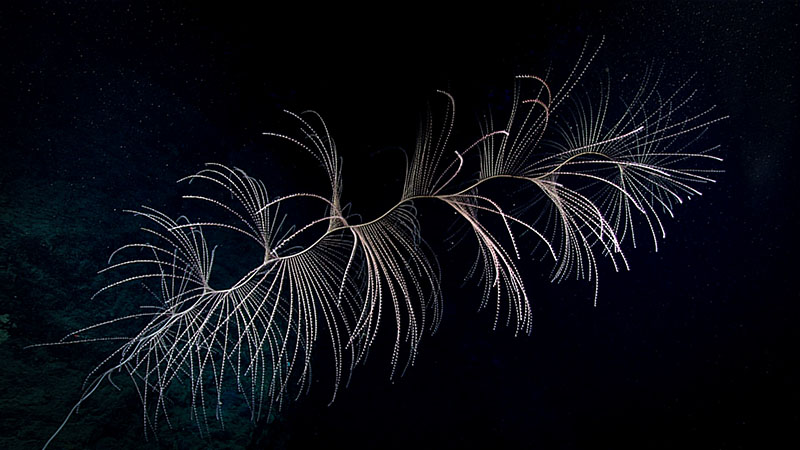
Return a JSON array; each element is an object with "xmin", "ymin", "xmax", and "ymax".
[{"xmin": 0, "ymin": 1, "xmax": 800, "ymax": 448}]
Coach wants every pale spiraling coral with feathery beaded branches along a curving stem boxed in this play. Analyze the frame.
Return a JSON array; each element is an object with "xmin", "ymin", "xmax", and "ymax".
[{"xmin": 36, "ymin": 37, "xmax": 724, "ymax": 447}]
